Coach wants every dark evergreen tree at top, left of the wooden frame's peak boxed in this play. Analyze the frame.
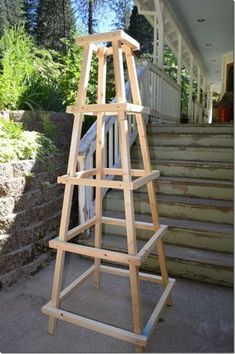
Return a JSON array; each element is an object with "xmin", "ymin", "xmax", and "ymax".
[{"xmin": 35, "ymin": 0, "xmax": 75, "ymax": 50}]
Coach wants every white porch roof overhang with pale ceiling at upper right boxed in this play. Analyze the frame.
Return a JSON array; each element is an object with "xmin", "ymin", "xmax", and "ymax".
[{"xmin": 134, "ymin": 0, "xmax": 233, "ymax": 92}]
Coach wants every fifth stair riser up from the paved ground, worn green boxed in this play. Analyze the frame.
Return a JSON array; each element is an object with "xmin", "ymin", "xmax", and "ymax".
[{"xmin": 133, "ymin": 162, "xmax": 233, "ymax": 180}]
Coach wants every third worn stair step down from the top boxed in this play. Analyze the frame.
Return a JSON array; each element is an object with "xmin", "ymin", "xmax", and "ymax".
[{"xmin": 131, "ymin": 145, "xmax": 233, "ymax": 163}]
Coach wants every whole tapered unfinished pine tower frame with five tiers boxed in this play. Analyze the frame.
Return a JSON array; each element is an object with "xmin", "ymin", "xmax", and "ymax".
[{"xmin": 42, "ymin": 31, "xmax": 175, "ymax": 351}]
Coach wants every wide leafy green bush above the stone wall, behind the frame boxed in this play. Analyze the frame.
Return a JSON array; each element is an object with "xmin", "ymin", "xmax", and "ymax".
[{"xmin": 0, "ymin": 27, "xmax": 114, "ymax": 115}]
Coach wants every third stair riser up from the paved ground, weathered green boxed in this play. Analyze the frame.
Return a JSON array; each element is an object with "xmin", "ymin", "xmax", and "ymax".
[{"xmin": 104, "ymin": 197, "xmax": 233, "ymax": 224}]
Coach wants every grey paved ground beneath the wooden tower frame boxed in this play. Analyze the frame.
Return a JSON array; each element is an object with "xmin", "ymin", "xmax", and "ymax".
[{"xmin": 0, "ymin": 255, "xmax": 233, "ymax": 353}]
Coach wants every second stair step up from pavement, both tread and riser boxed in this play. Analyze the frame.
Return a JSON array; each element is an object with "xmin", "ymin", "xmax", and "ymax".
[{"xmin": 103, "ymin": 211, "xmax": 234, "ymax": 253}]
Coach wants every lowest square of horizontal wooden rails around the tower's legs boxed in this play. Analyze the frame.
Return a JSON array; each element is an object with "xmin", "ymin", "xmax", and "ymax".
[{"xmin": 42, "ymin": 265, "xmax": 175, "ymax": 348}]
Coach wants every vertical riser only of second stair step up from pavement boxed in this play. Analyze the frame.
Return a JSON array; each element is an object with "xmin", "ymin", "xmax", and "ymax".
[{"xmin": 103, "ymin": 225, "xmax": 233, "ymax": 253}]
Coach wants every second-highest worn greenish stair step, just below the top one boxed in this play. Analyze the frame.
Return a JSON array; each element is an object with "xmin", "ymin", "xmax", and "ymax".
[{"xmin": 141, "ymin": 132, "xmax": 233, "ymax": 147}]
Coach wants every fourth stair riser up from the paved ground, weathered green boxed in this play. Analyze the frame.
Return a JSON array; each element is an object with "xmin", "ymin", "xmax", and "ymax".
[{"xmin": 154, "ymin": 181, "xmax": 233, "ymax": 200}]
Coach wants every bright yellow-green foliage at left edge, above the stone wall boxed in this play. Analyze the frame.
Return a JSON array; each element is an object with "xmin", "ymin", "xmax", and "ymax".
[{"xmin": 0, "ymin": 27, "xmax": 34, "ymax": 109}]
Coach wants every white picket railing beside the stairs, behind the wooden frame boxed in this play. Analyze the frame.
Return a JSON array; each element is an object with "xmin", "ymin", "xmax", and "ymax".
[{"xmin": 78, "ymin": 59, "xmax": 180, "ymax": 224}]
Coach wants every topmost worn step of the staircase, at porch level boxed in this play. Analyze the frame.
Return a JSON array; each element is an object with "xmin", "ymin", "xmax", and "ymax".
[{"xmin": 147, "ymin": 123, "xmax": 233, "ymax": 134}]
